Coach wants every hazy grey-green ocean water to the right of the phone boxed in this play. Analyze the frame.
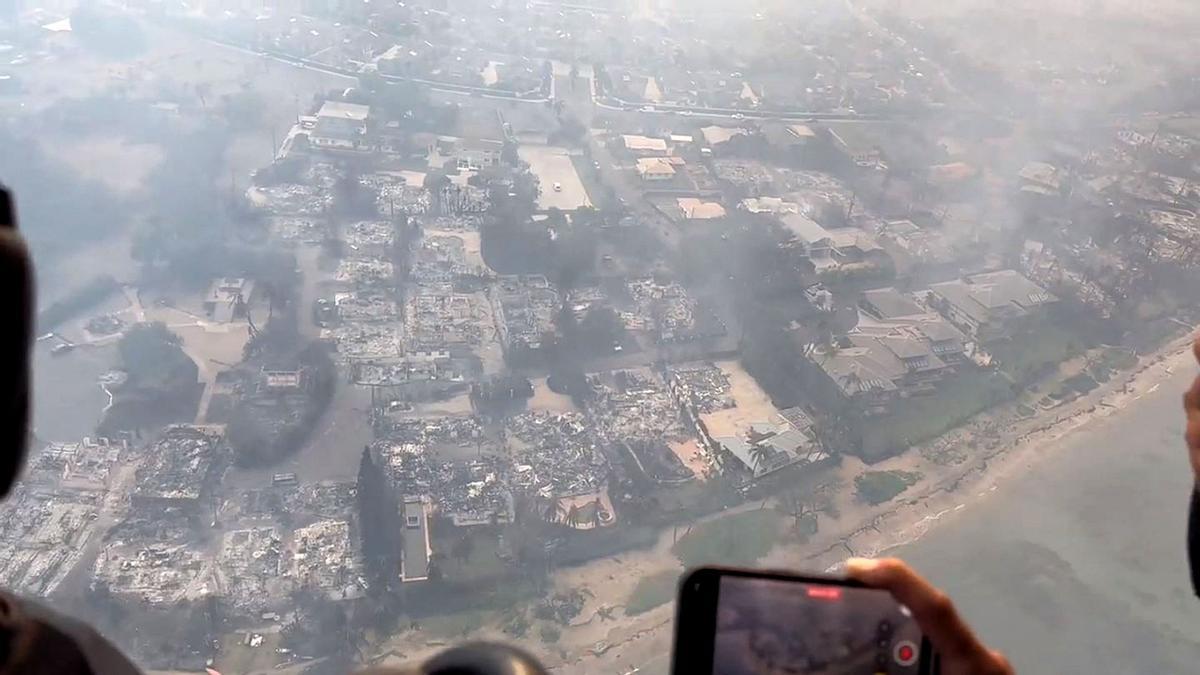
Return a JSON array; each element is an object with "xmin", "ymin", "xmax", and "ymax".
[{"xmin": 893, "ymin": 369, "xmax": 1200, "ymax": 674}]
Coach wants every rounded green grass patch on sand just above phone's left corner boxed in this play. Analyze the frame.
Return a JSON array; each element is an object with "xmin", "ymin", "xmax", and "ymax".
[{"xmin": 671, "ymin": 509, "xmax": 780, "ymax": 567}]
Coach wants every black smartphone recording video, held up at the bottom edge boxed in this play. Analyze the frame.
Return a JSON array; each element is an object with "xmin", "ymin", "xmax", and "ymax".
[{"xmin": 671, "ymin": 567, "xmax": 936, "ymax": 675}]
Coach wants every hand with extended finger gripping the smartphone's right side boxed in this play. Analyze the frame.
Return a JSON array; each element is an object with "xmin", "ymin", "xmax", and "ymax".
[{"xmin": 846, "ymin": 557, "xmax": 1013, "ymax": 675}]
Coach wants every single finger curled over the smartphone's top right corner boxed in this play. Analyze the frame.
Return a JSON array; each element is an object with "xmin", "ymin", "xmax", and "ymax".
[{"xmin": 846, "ymin": 558, "xmax": 986, "ymax": 661}]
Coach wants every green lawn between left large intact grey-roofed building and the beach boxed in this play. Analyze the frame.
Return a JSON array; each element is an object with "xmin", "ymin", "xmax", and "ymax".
[{"xmin": 863, "ymin": 371, "xmax": 1013, "ymax": 461}]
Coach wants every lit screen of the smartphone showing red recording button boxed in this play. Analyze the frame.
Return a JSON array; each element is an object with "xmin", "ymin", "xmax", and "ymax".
[{"xmin": 713, "ymin": 575, "xmax": 922, "ymax": 675}]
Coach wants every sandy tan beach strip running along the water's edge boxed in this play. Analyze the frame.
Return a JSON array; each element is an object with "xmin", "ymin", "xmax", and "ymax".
[{"xmin": 544, "ymin": 329, "xmax": 1195, "ymax": 673}]
